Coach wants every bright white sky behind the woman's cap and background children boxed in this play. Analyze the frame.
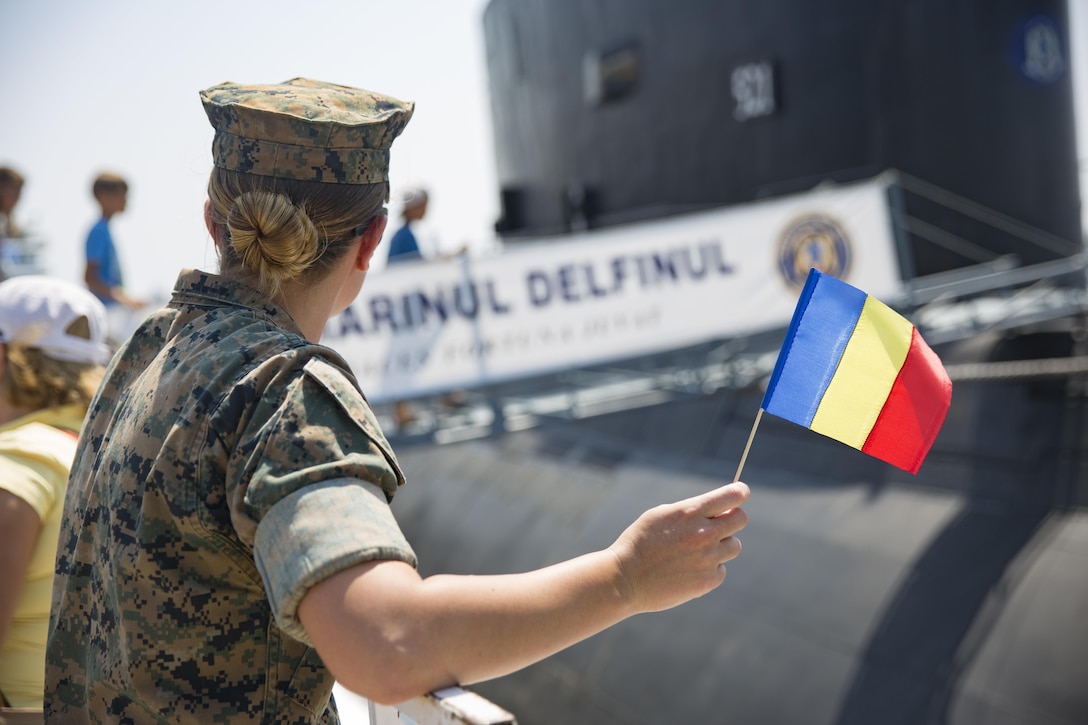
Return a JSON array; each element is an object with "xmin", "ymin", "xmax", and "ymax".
[{"xmin": 0, "ymin": 0, "xmax": 1088, "ymax": 299}]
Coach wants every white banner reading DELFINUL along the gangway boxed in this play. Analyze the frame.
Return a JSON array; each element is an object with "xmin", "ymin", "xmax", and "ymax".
[{"xmin": 323, "ymin": 177, "xmax": 902, "ymax": 401}]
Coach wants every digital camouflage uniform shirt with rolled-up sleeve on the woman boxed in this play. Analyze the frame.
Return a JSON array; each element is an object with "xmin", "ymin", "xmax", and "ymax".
[{"xmin": 46, "ymin": 271, "xmax": 416, "ymax": 723}]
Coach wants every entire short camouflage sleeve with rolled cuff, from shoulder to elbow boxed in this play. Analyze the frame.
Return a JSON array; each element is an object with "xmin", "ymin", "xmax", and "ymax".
[{"xmin": 224, "ymin": 358, "xmax": 416, "ymax": 643}]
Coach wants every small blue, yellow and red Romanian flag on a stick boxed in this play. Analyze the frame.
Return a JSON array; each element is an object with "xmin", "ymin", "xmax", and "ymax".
[{"xmin": 762, "ymin": 269, "xmax": 952, "ymax": 474}]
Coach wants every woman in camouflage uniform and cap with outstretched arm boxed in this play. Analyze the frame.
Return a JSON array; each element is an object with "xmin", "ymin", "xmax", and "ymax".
[{"xmin": 46, "ymin": 79, "xmax": 747, "ymax": 723}]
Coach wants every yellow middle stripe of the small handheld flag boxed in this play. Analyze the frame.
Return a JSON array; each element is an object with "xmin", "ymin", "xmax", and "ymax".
[{"xmin": 811, "ymin": 297, "xmax": 914, "ymax": 450}]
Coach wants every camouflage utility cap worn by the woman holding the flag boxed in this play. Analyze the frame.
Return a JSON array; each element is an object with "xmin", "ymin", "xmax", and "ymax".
[{"xmin": 200, "ymin": 78, "xmax": 416, "ymax": 184}]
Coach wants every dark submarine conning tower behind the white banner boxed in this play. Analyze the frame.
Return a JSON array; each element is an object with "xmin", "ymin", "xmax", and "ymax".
[{"xmin": 484, "ymin": 0, "xmax": 1083, "ymax": 278}]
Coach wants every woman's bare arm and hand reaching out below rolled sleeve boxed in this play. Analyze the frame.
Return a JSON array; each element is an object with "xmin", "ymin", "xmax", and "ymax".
[{"xmin": 298, "ymin": 483, "xmax": 749, "ymax": 703}]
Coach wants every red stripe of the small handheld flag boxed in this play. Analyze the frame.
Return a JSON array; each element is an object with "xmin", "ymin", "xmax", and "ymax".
[{"xmin": 862, "ymin": 329, "xmax": 952, "ymax": 474}]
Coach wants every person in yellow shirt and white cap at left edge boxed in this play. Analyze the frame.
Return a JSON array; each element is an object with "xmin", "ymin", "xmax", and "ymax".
[{"xmin": 0, "ymin": 277, "xmax": 109, "ymax": 709}]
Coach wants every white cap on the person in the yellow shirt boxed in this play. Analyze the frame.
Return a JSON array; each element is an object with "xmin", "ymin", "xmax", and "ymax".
[{"xmin": 0, "ymin": 275, "xmax": 110, "ymax": 365}]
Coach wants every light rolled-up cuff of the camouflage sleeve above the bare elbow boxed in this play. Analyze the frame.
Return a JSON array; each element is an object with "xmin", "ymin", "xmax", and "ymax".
[{"xmin": 254, "ymin": 479, "xmax": 417, "ymax": 643}]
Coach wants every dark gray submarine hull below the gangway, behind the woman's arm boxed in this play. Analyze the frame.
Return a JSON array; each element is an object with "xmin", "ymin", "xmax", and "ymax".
[{"xmin": 394, "ymin": 335, "xmax": 1088, "ymax": 725}]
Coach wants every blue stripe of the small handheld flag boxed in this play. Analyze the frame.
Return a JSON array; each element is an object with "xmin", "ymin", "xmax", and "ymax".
[{"xmin": 762, "ymin": 269, "xmax": 868, "ymax": 428}]
